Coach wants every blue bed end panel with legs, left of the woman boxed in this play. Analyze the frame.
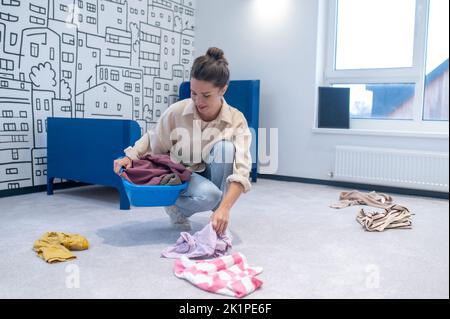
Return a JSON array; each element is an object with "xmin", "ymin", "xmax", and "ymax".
[{"xmin": 47, "ymin": 117, "xmax": 141, "ymax": 210}]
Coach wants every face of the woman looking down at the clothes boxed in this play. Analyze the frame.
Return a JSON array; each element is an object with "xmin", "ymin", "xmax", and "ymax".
[{"xmin": 191, "ymin": 78, "xmax": 228, "ymax": 121}]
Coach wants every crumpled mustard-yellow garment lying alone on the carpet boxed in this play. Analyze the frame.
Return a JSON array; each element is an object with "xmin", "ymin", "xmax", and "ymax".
[{"xmin": 33, "ymin": 232, "xmax": 89, "ymax": 263}]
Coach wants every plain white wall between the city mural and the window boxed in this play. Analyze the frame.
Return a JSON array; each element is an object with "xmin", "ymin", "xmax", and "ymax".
[{"xmin": 195, "ymin": 0, "xmax": 449, "ymax": 189}]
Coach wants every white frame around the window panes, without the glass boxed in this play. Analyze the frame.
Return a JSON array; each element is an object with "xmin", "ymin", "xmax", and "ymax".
[{"xmin": 326, "ymin": 0, "xmax": 449, "ymax": 135}]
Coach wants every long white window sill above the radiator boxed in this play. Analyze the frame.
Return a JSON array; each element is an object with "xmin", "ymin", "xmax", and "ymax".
[{"xmin": 312, "ymin": 127, "xmax": 448, "ymax": 140}]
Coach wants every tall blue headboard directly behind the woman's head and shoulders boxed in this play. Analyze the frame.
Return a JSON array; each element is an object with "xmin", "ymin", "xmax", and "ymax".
[{"xmin": 180, "ymin": 80, "xmax": 260, "ymax": 182}]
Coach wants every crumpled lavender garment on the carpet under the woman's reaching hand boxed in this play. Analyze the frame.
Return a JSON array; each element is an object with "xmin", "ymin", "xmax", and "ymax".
[{"xmin": 162, "ymin": 223, "xmax": 232, "ymax": 258}]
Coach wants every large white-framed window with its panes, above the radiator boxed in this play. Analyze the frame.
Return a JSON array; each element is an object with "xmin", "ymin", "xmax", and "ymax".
[{"xmin": 324, "ymin": 0, "xmax": 449, "ymax": 132}]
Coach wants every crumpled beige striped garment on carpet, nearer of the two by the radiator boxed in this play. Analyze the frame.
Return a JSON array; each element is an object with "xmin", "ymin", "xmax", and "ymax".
[{"xmin": 356, "ymin": 205, "xmax": 412, "ymax": 232}]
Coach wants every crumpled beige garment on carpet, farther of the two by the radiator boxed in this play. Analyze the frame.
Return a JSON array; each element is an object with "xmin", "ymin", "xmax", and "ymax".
[{"xmin": 330, "ymin": 191, "xmax": 392, "ymax": 209}]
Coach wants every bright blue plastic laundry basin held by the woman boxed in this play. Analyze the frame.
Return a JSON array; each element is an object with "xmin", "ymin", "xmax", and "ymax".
[{"xmin": 121, "ymin": 166, "xmax": 189, "ymax": 207}]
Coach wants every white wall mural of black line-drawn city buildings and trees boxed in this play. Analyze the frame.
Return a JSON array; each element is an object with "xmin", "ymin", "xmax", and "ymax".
[{"xmin": 0, "ymin": 0, "xmax": 195, "ymax": 192}]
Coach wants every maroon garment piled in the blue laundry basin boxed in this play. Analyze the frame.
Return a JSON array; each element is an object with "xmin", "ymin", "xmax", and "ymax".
[{"xmin": 120, "ymin": 154, "xmax": 192, "ymax": 185}]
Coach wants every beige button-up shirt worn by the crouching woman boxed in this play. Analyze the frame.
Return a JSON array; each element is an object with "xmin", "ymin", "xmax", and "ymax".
[{"xmin": 125, "ymin": 99, "xmax": 252, "ymax": 193}]
